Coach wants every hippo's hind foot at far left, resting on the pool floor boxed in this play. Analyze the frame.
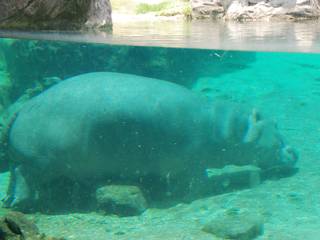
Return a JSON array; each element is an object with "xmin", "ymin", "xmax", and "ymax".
[{"xmin": 3, "ymin": 166, "xmax": 30, "ymax": 208}]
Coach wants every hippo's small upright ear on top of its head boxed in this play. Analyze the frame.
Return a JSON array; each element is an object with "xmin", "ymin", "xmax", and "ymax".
[{"xmin": 243, "ymin": 109, "xmax": 264, "ymax": 143}]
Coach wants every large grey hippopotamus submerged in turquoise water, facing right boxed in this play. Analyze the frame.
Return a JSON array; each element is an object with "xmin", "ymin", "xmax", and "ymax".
[{"xmin": 6, "ymin": 72, "xmax": 297, "ymax": 206}]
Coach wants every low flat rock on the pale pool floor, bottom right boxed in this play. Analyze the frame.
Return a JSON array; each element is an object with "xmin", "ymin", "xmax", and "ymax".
[{"xmin": 202, "ymin": 209, "xmax": 263, "ymax": 240}]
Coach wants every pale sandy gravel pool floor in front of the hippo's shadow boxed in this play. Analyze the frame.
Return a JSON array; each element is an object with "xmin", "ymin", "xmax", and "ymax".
[{"xmin": 25, "ymin": 164, "xmax": 320, "ymax": 240}]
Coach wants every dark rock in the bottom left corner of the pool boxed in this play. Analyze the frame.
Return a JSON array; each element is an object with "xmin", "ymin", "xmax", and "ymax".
[{"xmin": 0, "ymin": 212, "xmax": 63, "ymax": 240}]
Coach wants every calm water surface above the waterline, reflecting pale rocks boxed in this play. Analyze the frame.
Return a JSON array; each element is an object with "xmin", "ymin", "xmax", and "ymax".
[{"xmin": 0, "ymin": 20, "xmax": 320, "ymax": 52}]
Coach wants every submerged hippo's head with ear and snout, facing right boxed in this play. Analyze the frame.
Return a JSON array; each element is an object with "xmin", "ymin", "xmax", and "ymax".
[{"xmin": 245, "ymin": 111, "xmax": 298, "ymax": 169}]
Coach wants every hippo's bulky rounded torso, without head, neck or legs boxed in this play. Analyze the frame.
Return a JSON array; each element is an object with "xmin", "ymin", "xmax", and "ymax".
[{"xmin": 10, "ymin": 73, "xmax": 213, "ymax": 179}]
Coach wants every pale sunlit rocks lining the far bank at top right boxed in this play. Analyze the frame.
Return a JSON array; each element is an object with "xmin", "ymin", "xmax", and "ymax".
[{"xmin": 192, "ymin": 0, "xmax": 320, "ymax": 20}]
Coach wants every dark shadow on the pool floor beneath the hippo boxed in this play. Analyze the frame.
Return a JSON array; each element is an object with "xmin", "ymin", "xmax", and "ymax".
[{"xmin": 3, "ymin": 164, "xmax": 298, "ymax": 216}]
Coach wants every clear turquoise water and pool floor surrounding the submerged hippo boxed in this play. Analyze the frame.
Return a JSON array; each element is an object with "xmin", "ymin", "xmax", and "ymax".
[{"xmin": 0, "ymin": 39, "xmax": 320, "ymax": 239}]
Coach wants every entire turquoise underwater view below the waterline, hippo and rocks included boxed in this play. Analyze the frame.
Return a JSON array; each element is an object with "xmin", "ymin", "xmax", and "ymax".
[{"xmin": 0, "ymin": 38, "xmax": 320, "ymax": 240}]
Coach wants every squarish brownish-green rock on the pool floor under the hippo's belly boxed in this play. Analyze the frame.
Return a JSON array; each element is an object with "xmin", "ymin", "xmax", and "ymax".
[{"xmin": 96, "ymin": 185, "xmax": 147, "ymax": 216}]
